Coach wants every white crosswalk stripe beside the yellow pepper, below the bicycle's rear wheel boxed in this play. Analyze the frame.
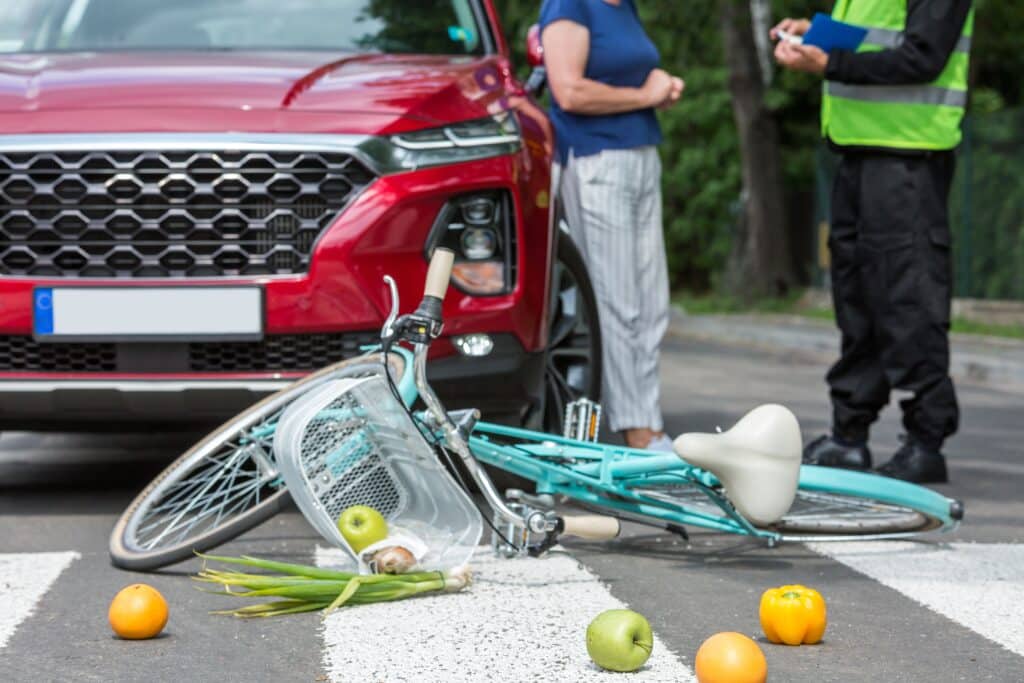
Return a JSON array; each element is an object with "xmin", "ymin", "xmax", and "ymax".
[{"xmin": 809, "ymin": 541, "xmax": 1024, "ymax": 656}]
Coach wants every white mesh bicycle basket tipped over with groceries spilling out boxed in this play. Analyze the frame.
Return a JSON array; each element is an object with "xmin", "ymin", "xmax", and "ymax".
[{"xmin": 273, "ymin": 376, "xmax": 482, "ymax": 571}]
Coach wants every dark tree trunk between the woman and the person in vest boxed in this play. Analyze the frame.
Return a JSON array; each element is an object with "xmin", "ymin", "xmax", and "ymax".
[{"xmin": 719, "ymin": 0, "xmax": 797, "ymax": 298}]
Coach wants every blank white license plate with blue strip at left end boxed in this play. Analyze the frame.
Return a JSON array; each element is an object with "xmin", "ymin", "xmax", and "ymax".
[{"xmin": 32, "ymin": 287, "xmax": 263, "ymax": 341}]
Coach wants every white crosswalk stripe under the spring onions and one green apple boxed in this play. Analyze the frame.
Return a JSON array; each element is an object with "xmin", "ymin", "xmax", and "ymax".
[{"xmin": 316, "ymin": 548, "xmax": 695, "ymax": 683}]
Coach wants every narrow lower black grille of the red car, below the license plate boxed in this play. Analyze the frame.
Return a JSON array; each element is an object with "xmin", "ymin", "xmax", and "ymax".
[{"xmin": 0, "ymin": 332, "xmax": 380, "ymax": 375}]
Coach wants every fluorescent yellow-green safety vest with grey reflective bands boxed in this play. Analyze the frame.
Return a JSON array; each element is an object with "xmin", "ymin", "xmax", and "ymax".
[{"xmin": 821, "ymin": 0, "xmax": 974, "ymax": 150}]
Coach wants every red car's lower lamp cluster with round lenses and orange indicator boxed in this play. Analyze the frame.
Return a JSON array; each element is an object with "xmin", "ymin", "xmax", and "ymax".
[{"xmin": 424, "ymin": 190, "xmax": 517, "ymax": 296}]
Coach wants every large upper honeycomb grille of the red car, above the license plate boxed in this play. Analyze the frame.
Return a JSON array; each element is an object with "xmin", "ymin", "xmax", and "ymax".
[{"xmin": 0, "ymin": 151, "xmax": 375, "ymax": 278}]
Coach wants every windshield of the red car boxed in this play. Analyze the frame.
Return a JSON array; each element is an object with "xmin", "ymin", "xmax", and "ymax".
[{"xmin": 0, "ymin": 0, "xmax": 484, "ymax": 54}]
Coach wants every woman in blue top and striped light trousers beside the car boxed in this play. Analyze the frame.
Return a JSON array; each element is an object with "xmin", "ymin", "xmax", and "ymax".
[{"xmin": 541, "ymin": 0, "xmax": 683, "ymax": 451}]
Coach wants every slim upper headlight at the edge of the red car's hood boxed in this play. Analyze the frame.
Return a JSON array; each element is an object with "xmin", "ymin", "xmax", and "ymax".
[{"xmin": 360, "ymin": 112, "xmax": 522, "ymax": 173}]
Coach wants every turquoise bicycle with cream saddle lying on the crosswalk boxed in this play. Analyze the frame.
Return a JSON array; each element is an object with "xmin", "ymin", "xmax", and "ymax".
[{"xmin": 110, "ymin": 249, "xmax": 964, "ymax": 570}]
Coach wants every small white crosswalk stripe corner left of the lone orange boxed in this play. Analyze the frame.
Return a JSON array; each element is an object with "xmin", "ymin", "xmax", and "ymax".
[{"xmin": 0, "ymin": 552, "xmax": 80, "ymax": 649}]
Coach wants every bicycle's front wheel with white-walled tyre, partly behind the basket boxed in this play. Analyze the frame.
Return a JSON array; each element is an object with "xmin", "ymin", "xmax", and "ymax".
[{"xmin": 110, "ymin": 353, "xmax": 404, "ymax": 571}]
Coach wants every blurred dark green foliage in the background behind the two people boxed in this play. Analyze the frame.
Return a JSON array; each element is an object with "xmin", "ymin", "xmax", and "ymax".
[{"xmin": 495, "ymin": 0, "xmax": 1024, "ymax": 296}]
